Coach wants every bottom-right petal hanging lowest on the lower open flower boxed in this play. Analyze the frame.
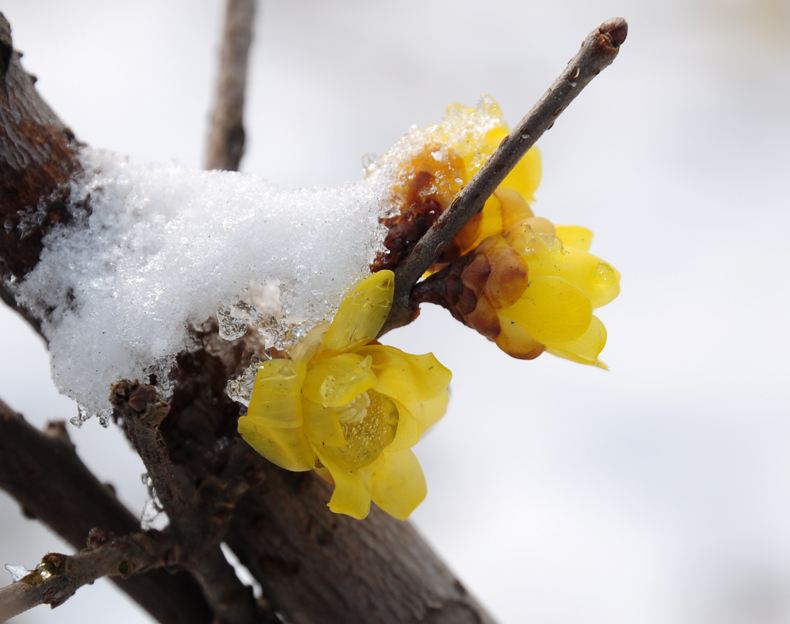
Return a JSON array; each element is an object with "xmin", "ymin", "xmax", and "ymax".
[{"xmin": 370, "ymin": 450, "xmax": 428, "ymax": 520}]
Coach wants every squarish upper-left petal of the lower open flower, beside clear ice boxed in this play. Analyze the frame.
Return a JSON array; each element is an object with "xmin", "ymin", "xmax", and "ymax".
[{"xmin": 247, "ymin": 360, "xmax": 307, "ymax": 427}]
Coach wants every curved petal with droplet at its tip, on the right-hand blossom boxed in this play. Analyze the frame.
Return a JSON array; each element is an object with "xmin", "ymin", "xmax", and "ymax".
[{"xmin": 525, "ymin": 247, "xmax": 620, "ymax": 308}]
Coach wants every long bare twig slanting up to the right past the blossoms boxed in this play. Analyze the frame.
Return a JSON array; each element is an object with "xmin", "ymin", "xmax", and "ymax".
[{"xmin": 379, "ymin": 17, "xmax": 628, "ymax": 336}]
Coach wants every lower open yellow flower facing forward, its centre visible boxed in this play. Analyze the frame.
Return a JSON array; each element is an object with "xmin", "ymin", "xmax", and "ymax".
[{"xmin": 239, "ymin": 271, "xmax": 451, "ymax": 520}]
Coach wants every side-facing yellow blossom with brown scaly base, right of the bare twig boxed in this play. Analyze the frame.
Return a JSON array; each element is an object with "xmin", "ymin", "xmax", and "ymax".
[{"xmin": 424, "ymin": 217, "xmax": 620, "ymax": 368}]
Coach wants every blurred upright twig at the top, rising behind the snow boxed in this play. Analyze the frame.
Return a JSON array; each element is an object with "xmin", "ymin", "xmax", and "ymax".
[{"xmin": 206, "ymin": 0, "xmax": 255, "ymax": 171}]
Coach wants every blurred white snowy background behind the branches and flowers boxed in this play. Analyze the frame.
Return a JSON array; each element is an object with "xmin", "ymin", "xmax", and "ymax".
[{"xmin": 0, "ymin": 0, "xmax": 790, "ymax": 624}]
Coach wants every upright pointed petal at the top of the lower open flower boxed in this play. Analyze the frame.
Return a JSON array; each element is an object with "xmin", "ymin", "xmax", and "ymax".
[{"xmin": 320, "ymin": 271, "xmax": 395, "ymax": 351}]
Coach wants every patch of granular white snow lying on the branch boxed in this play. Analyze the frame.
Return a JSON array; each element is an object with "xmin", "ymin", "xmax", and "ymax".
[{"xmin": 17, "ymin": 149, "xmax": 388, "ymax": 420}]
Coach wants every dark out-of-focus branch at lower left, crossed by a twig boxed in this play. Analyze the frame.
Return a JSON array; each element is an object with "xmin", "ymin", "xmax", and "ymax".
[{"xmin": 0, "ymin": 401, "xmax": 212, "ymax": 624}]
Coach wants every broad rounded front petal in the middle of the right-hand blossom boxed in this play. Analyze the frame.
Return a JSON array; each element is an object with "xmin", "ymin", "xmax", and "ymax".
[{"xmin": 501, "ymin": 276, "xmax": 592, "ymax": 345}]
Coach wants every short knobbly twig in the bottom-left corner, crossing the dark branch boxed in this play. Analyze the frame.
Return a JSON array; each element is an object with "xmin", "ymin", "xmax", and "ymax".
[{"xmin": 0, "ymin": 532, "xmax": 183, "ymax": 622}]
